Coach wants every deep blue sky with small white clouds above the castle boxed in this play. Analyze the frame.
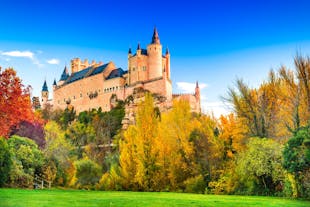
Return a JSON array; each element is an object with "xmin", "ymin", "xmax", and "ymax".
[{"xmin": 0, "ymin": 0, "xmax": 310, "ymax": 115}]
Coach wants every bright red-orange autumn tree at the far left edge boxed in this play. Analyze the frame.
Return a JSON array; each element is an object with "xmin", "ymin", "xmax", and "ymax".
[{"xmin": 0, "ymin": 67, "xmax": 35, "ymax": 137}]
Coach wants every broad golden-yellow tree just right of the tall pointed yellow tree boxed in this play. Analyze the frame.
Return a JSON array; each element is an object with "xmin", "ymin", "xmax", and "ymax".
[{"xmin": 158, "ymin": 100, "xmax": 199, "ymax": 190}]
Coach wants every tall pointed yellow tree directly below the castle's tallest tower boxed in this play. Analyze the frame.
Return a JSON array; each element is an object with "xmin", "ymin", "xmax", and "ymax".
[{"xmin": 120, "ymin": 93, "xmax": 160, "ymax": 191}]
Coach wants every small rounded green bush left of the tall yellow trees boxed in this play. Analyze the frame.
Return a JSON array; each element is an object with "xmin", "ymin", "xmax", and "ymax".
[{"xmin": 74, "ymin": 159, "xmax": 101, "ymax": 189}]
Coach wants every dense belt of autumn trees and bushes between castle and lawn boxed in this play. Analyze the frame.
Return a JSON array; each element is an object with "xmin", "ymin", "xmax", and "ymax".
[{"xmin": 0, "ymin": 56, "xmax": 310, "ymax": 198}]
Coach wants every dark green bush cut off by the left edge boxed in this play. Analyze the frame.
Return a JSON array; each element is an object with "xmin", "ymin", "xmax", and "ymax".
[{"xmin": 0, "ymin": 137, "xmax": 12, "ymax": 187}]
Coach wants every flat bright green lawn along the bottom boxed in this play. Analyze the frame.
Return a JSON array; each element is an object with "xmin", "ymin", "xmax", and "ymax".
[{"xmin": 0, "ymin": 189, "xmax": 310, "ymax": 207}]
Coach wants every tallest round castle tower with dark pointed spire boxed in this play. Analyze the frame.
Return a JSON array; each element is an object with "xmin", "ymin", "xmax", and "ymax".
[{"xmin": 147, "ymin": 27, "xmax": 163, "ymax": 79}]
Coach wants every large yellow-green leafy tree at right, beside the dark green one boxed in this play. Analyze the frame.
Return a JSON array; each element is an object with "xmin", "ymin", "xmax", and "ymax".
[{"xmin": 236, "ymin": 138, "xmax": 284, "ymax": 195}]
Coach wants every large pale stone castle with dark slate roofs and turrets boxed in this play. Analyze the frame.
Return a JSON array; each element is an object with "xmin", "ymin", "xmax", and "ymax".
[{"xmin": 41, "ymin": 28, "xmax": 201, "ymax": 113}]
